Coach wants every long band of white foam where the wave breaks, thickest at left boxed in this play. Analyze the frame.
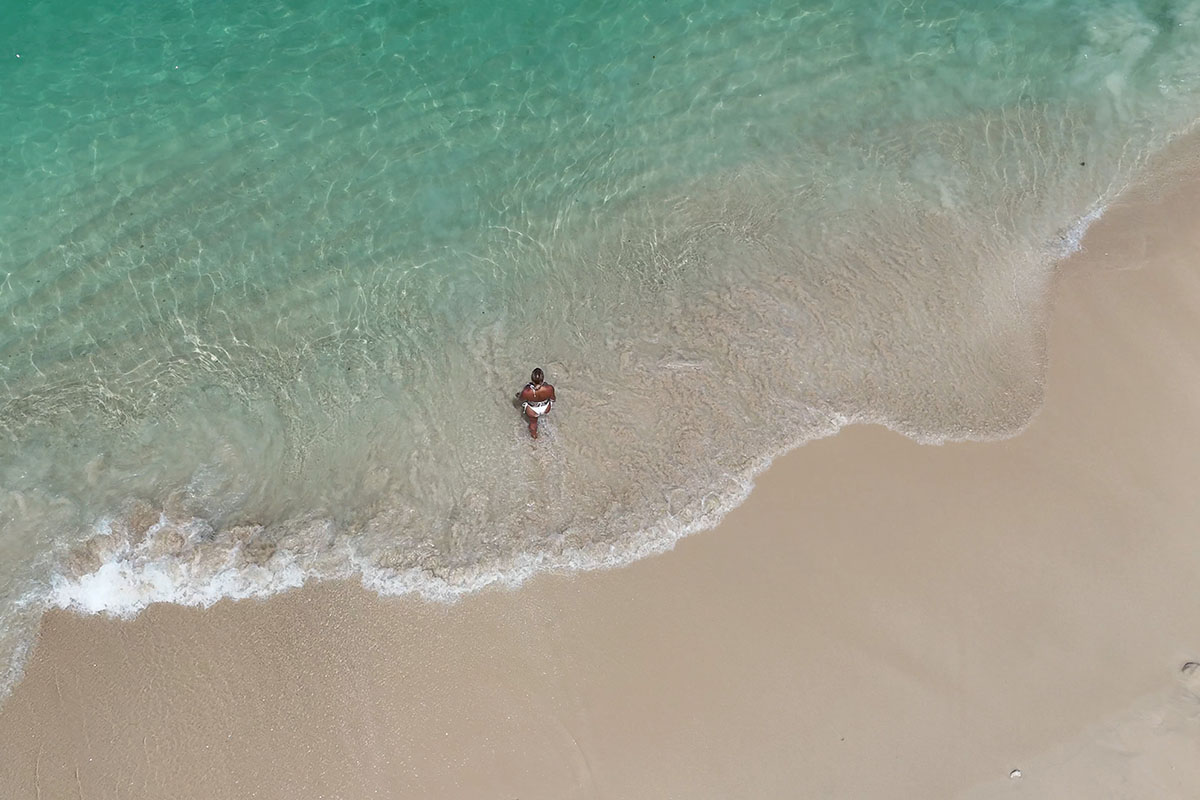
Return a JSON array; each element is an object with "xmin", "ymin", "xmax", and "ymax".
[{"xmin": 37, "ymin": 443, "xmax": 777, "ymax": 618}]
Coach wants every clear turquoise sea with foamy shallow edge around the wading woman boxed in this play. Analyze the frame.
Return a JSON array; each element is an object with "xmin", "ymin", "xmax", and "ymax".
[{"xmin": 0, "ymin": 0, "xmax": 1200, "ymax": 695}]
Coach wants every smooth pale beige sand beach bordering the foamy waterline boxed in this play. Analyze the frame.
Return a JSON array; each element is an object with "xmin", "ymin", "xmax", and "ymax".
[{"xmin": 0, "ymin": 145, "xmax": 1200, "ymax": 800}]
